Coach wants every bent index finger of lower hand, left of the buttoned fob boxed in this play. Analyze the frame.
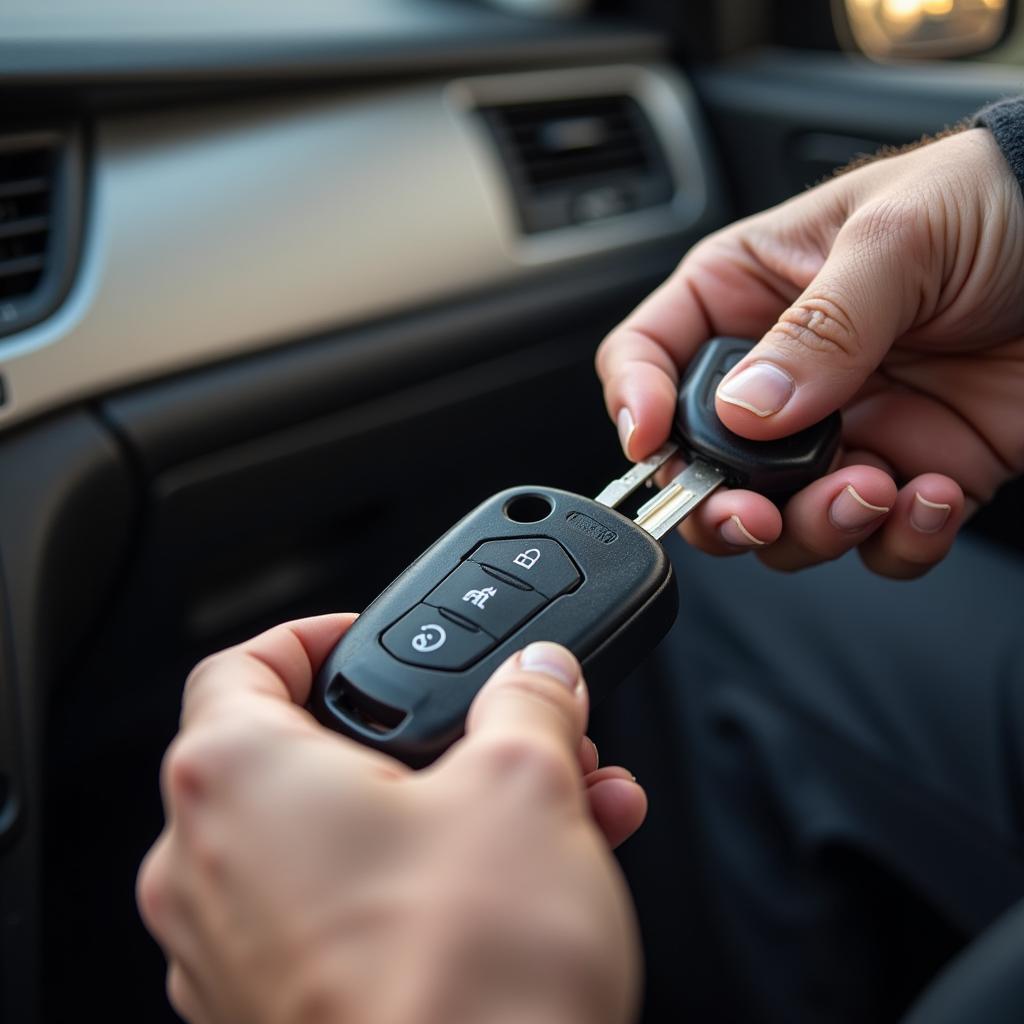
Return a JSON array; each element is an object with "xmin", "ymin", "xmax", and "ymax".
[{"xmin": 181, "ymin": 613, "xmax": 355, "ymax": 726}]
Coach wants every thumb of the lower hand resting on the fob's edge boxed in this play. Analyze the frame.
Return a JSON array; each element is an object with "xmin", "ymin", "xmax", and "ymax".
[{"xmin": 464, "ymin": 641, "xmax": 588, "ymax": 774}]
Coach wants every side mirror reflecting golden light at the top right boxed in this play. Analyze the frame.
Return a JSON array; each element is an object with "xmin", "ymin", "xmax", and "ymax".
[{"xmin": 833, "ymin": 0, "xmax": 1013, "ymax": 60}]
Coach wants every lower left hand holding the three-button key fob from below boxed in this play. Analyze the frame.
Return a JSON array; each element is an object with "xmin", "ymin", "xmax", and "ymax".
[{"xmin": 137, "ymin": 615, "xmax": 646, "ymax": 1024}]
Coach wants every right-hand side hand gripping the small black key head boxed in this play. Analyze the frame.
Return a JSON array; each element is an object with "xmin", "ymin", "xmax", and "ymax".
[{"xmin": 597, "ymin": 128, "xmax": 1024, "ymax": 578}]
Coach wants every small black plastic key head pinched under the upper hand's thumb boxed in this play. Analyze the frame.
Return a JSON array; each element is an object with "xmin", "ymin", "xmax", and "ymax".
[{"xmin": 675, "ymin": 338, "xmax": 842, "ymax": 505}]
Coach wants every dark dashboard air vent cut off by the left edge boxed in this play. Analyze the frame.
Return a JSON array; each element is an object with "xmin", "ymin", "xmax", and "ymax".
[{"xmin": 0, "ymin": 129, "xmax": 81, "ymax": 335}]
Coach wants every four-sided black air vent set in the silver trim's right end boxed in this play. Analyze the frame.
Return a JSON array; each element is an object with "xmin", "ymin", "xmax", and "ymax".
[{"xmin": 480, "ymin": 96, "xmax": 674, "ymax": 232}]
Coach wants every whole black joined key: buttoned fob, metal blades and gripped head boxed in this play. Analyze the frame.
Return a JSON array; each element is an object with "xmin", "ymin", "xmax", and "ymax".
[{"xmin": 309, "ymin": 338, "xmax": 840, "ymax": 767}]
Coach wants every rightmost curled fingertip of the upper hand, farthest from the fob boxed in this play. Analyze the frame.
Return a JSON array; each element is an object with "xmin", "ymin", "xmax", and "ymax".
[{"xmin": 859, "ymin": 473, "xmax": 964, "ymax": 580}]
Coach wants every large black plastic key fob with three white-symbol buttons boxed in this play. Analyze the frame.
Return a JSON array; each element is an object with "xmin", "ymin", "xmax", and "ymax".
[{"xmin": 309, "ymin": 487, "xmax": 679, "ymax": 767}]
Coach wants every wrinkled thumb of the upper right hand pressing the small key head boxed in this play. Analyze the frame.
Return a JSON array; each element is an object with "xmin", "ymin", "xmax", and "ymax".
[{"xmin": 715, "ymin": 214, "xmax": 927, "ymax": 440}]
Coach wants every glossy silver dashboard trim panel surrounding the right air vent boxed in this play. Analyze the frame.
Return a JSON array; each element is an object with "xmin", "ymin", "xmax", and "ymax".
[{"xmin": 0, "ymin": 58, "xmax": 721, "ymax": 430}]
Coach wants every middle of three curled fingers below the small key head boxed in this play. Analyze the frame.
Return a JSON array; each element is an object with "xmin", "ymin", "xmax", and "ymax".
[{"xmin": 758, "ymin": 466, "xmax": 896, "ymax": 571}]
